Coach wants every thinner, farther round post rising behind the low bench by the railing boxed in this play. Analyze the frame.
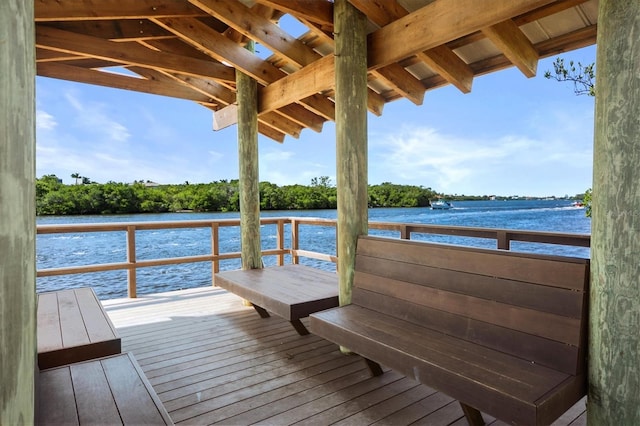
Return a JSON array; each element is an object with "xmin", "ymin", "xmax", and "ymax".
[{"xmin": 236, "ymin": 46, "xmax": 262, "ymax": 269}]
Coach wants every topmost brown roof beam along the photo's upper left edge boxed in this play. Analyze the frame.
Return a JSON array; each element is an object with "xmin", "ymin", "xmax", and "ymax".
[{"xmin": 34, "ymin": 0, "xmax": 206, "ymax": 22}]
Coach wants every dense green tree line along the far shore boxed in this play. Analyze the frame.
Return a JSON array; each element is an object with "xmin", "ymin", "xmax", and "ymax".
[{"xmin": 36, "ymin": 175, "xmax": 438, "ymax": 215}]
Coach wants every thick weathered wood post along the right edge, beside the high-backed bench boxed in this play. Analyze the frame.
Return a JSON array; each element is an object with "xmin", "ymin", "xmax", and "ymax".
[{"xmin": 587, "ymin": 0, "xmax": 640, "ymax": 425}]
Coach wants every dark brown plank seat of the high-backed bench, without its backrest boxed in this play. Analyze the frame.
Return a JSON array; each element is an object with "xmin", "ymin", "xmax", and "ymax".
[{"xmin": 311, "ymin": 305, "xmax": 586, "ymax": 424}]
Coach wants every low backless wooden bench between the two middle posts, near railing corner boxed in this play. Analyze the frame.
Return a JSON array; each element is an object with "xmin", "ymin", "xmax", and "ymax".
[{"xmin": 215, "ymin": 265, "xmax": 338, "ymax": 335}]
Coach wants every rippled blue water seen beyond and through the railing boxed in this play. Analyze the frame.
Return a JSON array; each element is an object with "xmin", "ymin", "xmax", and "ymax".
[{"xmin": 36, "ymin": 200, "xmax": 591, "ymax": 299}]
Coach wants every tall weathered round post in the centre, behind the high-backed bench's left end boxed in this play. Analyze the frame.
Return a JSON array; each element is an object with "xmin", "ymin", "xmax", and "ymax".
[{"xmin": 333, "ymin": 0, "xmax": 368, "ymax": 305}]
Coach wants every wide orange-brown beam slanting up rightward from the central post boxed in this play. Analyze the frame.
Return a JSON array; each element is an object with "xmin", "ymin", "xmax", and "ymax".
[{"xmin": 368, "ymin": 0, "xmax": 553, "ymax": 69}]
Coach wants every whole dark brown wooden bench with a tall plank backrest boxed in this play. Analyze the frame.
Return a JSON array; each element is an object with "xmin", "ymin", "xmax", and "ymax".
[{"xmin": 310, "ymin": 237, "xmax": 589, "ymax": 424}]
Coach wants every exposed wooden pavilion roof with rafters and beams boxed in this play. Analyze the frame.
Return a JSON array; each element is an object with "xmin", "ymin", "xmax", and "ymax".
[{"xmin": 34, "ymin": 0, "xmax": 598, "ymax": 142}]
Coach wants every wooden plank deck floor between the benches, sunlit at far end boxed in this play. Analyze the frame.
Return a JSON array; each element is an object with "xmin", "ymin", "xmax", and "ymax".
[{"xmin": 104, "ymin": 288, "xmax": 586, "ymax": 425}]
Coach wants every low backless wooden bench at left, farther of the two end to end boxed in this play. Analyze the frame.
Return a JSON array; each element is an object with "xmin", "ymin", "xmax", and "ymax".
[{"xmin": 37, "ymin": 287, "xmax": 121, "ymax": 369}]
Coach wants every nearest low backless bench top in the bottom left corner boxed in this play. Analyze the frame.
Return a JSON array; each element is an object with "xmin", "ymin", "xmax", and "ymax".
[{"xmin": 36, "ymin": 353, "xmax": 173, "ymax": 425}]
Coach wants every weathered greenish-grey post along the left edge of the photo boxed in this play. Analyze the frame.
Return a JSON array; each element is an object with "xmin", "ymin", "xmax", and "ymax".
[{"xmin": 0, "ymin": 0, "xmax": 36, "ymax": 425}]
